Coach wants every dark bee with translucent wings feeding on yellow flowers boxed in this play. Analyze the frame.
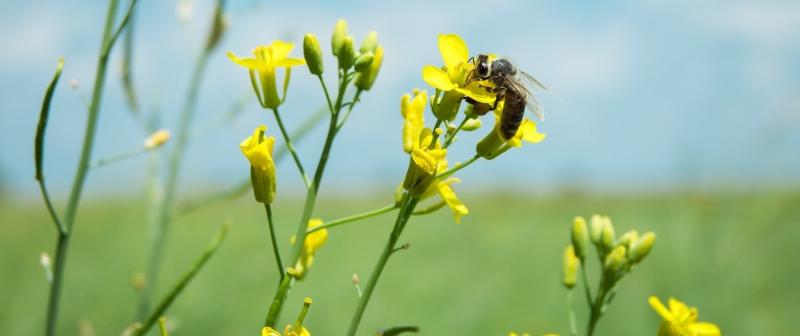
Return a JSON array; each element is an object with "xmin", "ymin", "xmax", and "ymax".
[{"xmin": 467, "ymin": 54, "xmax": 547, "ymax": 140}]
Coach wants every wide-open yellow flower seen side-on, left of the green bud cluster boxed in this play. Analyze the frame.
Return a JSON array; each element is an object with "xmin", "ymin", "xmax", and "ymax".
[{"xmin": 228, "ymin": 40, "xmax": 306, "ymax": 109}]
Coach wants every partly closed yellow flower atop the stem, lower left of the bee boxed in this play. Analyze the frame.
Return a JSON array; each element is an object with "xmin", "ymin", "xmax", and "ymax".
[{"xmin": 403, "ymin": 128, "xmax": 447, "ymax": 196}]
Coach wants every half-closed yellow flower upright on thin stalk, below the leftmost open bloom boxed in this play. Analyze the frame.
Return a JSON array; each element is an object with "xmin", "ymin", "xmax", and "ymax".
[{"xmin": 239, "ymin": 125, "xmax": 275, "ymax": 204}]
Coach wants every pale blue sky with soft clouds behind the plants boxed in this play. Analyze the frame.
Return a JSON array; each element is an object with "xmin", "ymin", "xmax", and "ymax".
[{"xmin": 0, "ymin": 0, "xmax": 800, "ymax": 196}]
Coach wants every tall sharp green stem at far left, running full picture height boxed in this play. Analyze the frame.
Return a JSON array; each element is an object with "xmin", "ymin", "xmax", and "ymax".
[{"xmin": 45, "ymin": 0, "xmax": 128, "ymax": 336}]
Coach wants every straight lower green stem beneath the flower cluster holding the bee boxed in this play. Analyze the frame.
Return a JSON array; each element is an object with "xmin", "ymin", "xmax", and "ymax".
[{"xmin": 347, "ymin": 195, "xmax": 419, "ymax": 336}]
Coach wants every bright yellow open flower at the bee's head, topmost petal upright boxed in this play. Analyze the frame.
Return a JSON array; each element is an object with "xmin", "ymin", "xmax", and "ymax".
[{"xmin": 422, "ymin": 34, "xmax": 496, "ymax": 120}]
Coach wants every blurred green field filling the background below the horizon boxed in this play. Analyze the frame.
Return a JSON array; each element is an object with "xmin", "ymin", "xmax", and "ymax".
[{"xmin": 0, "ymin": 193, "xmax": 800, "ymax": 336}]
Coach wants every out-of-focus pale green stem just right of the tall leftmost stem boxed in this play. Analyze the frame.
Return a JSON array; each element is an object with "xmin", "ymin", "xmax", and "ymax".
[{"xmin": 139, "ymin": 37, "xmax": 209, "ymax": 319}]
